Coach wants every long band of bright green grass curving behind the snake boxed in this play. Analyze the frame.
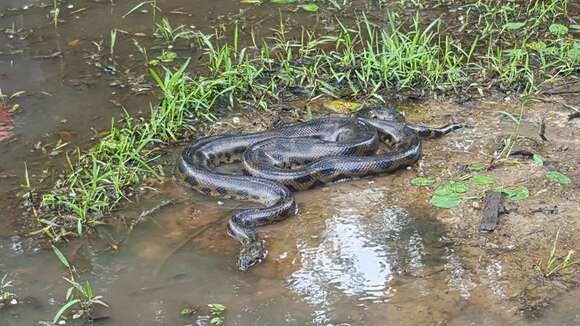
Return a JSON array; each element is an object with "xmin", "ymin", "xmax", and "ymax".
[{"xmin": 38, "ymin": 0, "xmax": 580, "ymax": 240}]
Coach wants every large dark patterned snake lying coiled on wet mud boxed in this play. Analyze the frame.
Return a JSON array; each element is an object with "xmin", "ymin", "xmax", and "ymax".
[{"xmin": 179, "ymin": 106, "xmax": 468, "ymax": 271}]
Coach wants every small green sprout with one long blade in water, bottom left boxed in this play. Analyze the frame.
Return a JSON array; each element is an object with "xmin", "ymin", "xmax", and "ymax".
[{"xmin": 52, "ymin": 246, "xmax": 109, "ymax": 324}]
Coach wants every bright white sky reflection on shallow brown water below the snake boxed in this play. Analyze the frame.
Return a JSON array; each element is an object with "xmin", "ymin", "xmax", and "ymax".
[{"xmin": 288, "ymin": 189, "xmax": 446, "ymax": 322}]
